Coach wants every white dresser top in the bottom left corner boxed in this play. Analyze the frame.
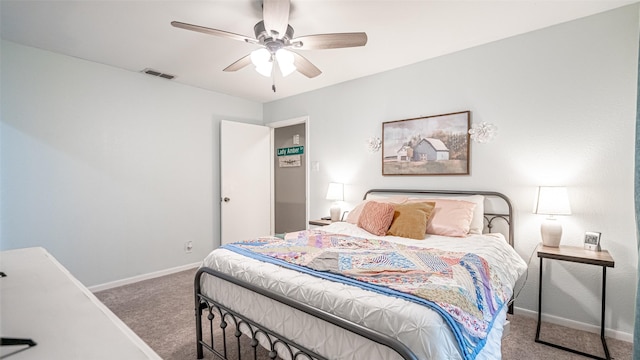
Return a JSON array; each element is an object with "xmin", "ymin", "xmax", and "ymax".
[{"xmin": 0, "ymin": 247, "xmax": 161, "ymax": 360}]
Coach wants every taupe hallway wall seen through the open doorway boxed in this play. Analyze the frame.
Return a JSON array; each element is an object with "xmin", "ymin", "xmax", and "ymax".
[{"xmin": 274, "ymin": 124, "xmax": 308, "ymax": 233}]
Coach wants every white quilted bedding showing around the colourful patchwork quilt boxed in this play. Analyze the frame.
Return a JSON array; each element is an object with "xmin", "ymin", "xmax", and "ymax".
[{"xmin": 202, "ymin": 222, "xmax": 526, "ymax": 360}]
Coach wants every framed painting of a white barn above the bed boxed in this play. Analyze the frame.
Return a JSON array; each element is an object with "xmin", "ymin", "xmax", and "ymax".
[{"xmin": 382, "ymin": 111, "xmax": 471, "ymax": 175}]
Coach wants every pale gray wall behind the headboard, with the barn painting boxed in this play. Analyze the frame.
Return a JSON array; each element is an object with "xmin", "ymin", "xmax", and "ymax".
[{"xmin": 264, "ymin": 4, "xmax": 639, "ymax": 340}]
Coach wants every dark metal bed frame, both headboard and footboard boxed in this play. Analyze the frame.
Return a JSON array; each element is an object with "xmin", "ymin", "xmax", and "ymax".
[{"xmin": 194, "ymin": 189, "xmax": 514, "ymax": 360}]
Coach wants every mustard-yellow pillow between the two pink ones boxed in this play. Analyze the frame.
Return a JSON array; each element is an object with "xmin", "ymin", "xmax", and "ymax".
[{"xmin": 387, "ymin": 202, "xmax": 436, "ymax": 240}]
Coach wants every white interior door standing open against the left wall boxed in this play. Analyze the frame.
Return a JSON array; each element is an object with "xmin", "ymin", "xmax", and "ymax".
[{"xmin": 220, "ymin": 120, "xmax": 271, "ymax": 245}]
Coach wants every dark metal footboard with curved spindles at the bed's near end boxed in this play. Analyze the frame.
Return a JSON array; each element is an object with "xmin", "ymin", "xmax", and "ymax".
[{"xmin": 194, "ymin": 267, "xmax": 417, "ymax": 360}]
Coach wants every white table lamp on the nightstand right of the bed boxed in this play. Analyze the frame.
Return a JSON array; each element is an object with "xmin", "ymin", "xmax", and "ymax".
[{"xmin": 533, "ymin": 186, "xmax": 571, "ymax": 247}]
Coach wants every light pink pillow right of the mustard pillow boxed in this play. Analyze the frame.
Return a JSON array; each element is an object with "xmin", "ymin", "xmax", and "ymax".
[{"xmin": 427, "ymin": 199, "xmax": 476, "ymax": 237}]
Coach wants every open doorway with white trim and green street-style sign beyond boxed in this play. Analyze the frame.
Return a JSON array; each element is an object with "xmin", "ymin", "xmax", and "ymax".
[{"xmin": 269, "ymin": 118, "xmax": 309, "ymax": 234}]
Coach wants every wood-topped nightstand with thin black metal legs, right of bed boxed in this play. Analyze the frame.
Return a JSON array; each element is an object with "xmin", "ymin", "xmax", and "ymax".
[{"xmin": 536, "ymin": 245, "xmax": 615, "ymax": 360}]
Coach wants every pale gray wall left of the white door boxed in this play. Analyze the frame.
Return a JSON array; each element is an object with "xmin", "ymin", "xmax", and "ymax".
[{"xmin": 0, "ymin": 41, "xmax": 262, "ymax": 286}]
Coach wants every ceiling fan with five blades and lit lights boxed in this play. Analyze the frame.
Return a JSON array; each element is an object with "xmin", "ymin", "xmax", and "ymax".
[{"xmin": 171, "ymin": 0, "xmax": 367, "ymax": 91}]
